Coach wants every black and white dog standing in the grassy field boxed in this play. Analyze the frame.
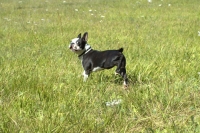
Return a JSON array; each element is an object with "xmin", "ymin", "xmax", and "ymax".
[{"xmin": 69, "ymin": 32, "xmax": 128, "ymax": 87}]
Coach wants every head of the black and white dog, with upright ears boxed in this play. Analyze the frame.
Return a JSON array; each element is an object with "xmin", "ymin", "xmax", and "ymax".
[{"xmin": 69, "ymin": 32, "xmax": 88, "ymax": 55}]
